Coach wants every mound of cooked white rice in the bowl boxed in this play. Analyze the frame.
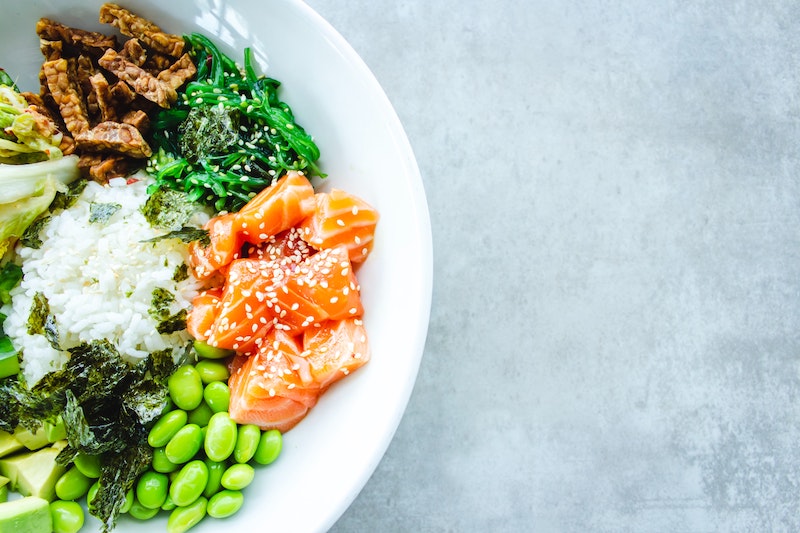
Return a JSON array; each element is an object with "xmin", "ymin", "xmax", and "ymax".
[{"xmin": 4, "ymin": 180, "xmax": 208, "ymax": 384}]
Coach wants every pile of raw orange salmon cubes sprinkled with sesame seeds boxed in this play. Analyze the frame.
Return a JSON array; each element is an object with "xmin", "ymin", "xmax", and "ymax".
[{"xmin": 187, "ymin": 172, "xmax": 379, "ymax": 432}]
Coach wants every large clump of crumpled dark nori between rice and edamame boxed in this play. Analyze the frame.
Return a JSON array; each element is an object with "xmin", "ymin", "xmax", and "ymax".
[{"xmin": 0, "ymin": 340, "xmax": 175, "ymax": 531}]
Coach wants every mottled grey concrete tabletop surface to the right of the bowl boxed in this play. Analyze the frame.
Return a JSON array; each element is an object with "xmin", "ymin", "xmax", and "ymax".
[{"xmin": 309, "ymin": 0, "xmax": 800, "ymax": 533}]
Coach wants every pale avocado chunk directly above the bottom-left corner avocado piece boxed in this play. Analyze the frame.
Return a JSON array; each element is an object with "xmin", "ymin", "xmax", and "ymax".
[{"xmin": 0, "ymin": 441, "xmax": 66, "ymax": 502}]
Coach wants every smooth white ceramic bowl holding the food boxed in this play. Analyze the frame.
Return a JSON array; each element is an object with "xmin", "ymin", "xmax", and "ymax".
[{"xmin": 0, "ymin": 0, "xmax": 432, "ymax": 532}]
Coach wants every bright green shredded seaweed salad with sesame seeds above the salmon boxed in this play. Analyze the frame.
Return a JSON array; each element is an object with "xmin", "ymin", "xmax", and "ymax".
[{"xmin": 148, "ymin": 33, "xmax": 324, "ymax": 211}]
